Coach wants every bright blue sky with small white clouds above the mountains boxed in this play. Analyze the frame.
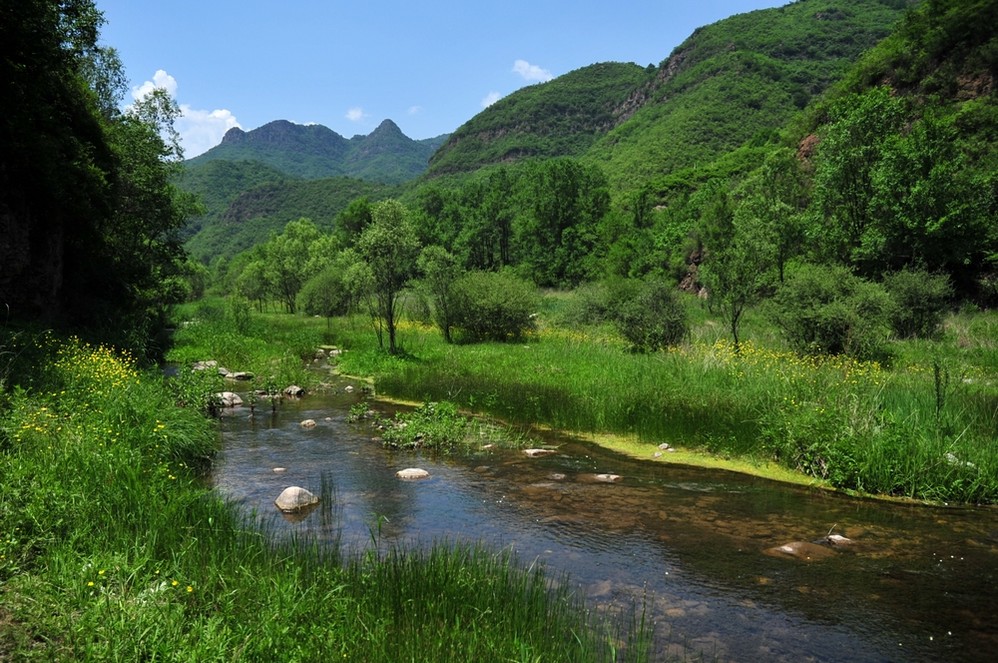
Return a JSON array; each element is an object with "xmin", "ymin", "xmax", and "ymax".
[{"xmin": 95, "ymin": 0, "xmax": 789, "ymax": 158}]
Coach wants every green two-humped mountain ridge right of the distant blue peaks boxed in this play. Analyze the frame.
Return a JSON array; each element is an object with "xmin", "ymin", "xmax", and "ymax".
[{"xmin": 426, "ymin": 0, "xmax": 914, "ymax": 190}]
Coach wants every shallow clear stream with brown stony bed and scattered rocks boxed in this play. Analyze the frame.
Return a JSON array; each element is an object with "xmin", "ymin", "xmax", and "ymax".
[{"xmin": 214, "ymin": 385, "xmax": 998, "ymax": 661}]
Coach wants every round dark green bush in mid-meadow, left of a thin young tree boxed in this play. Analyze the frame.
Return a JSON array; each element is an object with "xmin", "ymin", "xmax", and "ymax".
[{"xmin": 608, "ymin": 280, "xmax": 689, "ymax": 352}]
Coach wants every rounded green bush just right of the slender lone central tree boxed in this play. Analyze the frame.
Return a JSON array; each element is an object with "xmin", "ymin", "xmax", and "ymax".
[{"xmin": 453, "ymin": 271, "xmax": 539, "ymax": 341}]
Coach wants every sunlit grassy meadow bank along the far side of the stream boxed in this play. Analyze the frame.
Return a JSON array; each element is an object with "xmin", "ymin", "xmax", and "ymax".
[{"xmin": 308, "ymin": 295, "xmax": 998, "ymax": 503}]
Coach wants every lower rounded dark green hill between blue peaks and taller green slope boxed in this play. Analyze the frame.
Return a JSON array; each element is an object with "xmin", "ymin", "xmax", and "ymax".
[{"xmin": 429, "ymin": 63, "xmax": 650, "ymax": 176}]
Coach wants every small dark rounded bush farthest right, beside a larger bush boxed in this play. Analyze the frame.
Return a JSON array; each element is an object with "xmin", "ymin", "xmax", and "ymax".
[{"xmin": 884, "ymin": 269, "xmax": 953, "ymax": 338}]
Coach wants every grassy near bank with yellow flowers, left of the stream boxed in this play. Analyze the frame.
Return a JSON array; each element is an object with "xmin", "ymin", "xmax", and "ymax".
[{"xmin": 0, "ymin": 330, "xmax": 641, "ymax": 661}]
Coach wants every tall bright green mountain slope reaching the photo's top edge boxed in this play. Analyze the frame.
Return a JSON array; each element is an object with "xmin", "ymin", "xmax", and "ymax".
[{"xmin": 587, "ymin": 0, "xmax": 911, "ymax": 190}]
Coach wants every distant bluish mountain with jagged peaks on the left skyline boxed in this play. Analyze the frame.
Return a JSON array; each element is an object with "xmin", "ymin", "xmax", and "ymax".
[{"xmin": 186, "ymin": 120, "xmax": 447, "ymax": 184}]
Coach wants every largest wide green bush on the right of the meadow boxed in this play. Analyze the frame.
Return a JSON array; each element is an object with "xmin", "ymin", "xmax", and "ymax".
[{"xmin": 770, "ymin": 265, "xmax": 893, "ymax": 359}]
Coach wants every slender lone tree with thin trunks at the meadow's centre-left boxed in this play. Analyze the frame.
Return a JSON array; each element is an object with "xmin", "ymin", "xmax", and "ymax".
[{"xmin": 357, "ymin": 199, "xmax": 419, "ymax": 355}]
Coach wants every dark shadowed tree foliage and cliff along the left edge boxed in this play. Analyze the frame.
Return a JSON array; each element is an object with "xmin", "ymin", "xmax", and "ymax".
[{"xmin": 0, "ymin": 0, "xmax": 193, "ymax": 364}]
